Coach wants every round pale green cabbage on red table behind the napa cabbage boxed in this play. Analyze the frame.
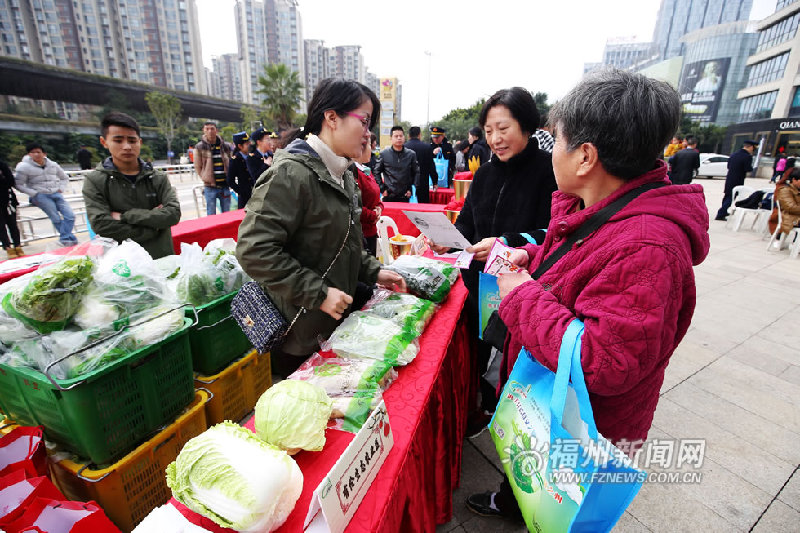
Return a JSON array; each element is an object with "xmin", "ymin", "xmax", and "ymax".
[{"xmin": 255, "ymin": 379, "xmax": 331, "ymax": 453}]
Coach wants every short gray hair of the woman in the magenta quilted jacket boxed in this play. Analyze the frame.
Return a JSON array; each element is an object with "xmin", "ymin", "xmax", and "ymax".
[{"xmin": 549, "ymin": 68, "xmax": 681, "ymax": 180}]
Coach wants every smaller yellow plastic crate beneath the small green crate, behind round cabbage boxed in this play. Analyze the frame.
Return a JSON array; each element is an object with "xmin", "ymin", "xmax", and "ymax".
[{"xmin": 194, "ymin": 350, "xmax": 272, "ymax": 426}]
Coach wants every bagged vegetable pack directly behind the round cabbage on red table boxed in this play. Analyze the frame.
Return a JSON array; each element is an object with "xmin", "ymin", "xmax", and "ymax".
[{"xmin": 289, "ymin": 353, "xmax": 397, "ymax": 432}]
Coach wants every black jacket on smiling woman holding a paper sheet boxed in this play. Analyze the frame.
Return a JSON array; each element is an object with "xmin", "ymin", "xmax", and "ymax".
[{"xmin": 455, "ymin": 138, "xmax": 558, "ymax": 291}]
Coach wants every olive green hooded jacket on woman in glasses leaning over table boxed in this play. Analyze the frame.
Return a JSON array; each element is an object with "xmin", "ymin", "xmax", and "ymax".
[{"xmin": 236, "ymin": 139, "xmax": 380, "ymax": 355}]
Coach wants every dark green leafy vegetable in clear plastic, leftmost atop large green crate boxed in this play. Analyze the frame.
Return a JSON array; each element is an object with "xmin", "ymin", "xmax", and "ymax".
[{"xmin": 2, "ymin": 257, "xmax": 94, "ymax": 333}]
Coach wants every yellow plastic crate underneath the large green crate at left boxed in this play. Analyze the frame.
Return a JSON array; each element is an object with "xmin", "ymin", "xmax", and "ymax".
[{"xmin": 50, "ymin": 390, "xmax": 212, "ymax": 531}]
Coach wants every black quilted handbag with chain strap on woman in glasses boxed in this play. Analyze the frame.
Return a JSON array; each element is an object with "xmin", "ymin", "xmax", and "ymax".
[{"xmin": 231, "ymin": 217, "xmax": 353, "ymax": 353}]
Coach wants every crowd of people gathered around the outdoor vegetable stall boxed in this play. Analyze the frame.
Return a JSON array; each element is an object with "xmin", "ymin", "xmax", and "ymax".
[{"xmin": 9, "ymin": 69, "xmax": 800, "ymax": 516}]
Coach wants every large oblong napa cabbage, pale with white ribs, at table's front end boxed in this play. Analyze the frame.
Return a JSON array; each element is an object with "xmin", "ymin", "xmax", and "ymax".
[{"xmin": 166, "ymin": 422, "xmax": 303, "ymax": 532}]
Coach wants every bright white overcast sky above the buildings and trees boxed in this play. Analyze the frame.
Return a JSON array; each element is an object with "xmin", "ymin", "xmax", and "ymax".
[{"xmin": 196, "ymin": 0, "xmax": 775, "ymax": 124}]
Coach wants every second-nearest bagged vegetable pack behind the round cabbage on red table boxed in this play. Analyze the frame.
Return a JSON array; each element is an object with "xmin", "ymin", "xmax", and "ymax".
[{"xmin": 322, "ymin": 311, "xmax": 419, "ymax": 366}]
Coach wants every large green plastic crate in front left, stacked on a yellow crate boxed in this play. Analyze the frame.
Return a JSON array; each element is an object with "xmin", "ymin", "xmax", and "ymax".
[{"xmin": 0, "ymin": 319, "xmax": 194, "ymax": 465}]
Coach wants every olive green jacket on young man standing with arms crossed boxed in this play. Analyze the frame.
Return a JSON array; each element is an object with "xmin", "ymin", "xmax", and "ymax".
[{"xmin": 83, "ymin": 157, "xmax": 181, "ymax": 259}]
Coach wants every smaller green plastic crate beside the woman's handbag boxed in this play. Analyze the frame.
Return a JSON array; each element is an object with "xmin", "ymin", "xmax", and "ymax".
[{"xmin": 186, "ymin": 292, "xmax": 253, "ymax": 376}]
